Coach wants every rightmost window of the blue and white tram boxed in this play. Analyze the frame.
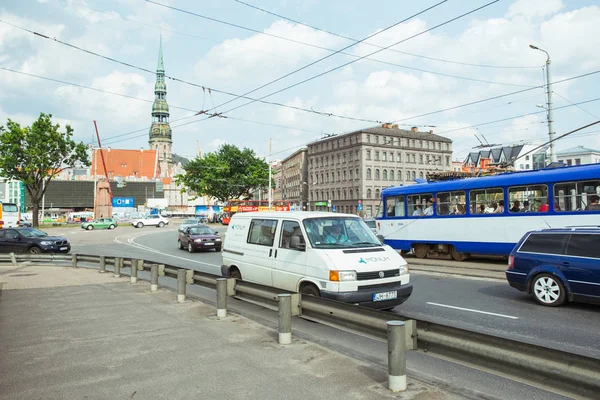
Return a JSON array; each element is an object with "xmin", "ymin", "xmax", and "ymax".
[{"xmin": 554, "ymin": 180, "xmax": 600, "ymax": 211}]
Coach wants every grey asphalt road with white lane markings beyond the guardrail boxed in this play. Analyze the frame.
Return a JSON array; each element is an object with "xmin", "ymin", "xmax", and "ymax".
[{"xmin": 65, "ymin": 227, "xmax": 600, "ymax": 359}]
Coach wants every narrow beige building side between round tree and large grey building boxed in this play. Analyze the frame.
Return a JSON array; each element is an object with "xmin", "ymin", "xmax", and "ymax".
[{"xmin": 280, "ymin": 148, "xmax": 308, "ymax": 210}]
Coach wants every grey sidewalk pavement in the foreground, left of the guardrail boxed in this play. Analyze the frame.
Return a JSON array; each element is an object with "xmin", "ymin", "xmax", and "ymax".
[{"xmin": 0, "ymin": 265, "xmax": 463, "ymax": 400}]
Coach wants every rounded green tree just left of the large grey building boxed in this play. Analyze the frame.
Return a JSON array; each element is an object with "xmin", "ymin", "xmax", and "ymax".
[{"xmin": 177, "ymin": 144, "xmax": 269, "ymax": 202}]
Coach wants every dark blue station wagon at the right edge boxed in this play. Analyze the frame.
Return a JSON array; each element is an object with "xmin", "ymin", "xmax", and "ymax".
[{"xmin": 506, "ymin": 227, "xmax": 600, "ymax": 307}]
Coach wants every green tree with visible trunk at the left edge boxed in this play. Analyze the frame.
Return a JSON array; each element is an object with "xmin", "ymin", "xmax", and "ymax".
[{"xmin": 0, "ymin": 113, "xmax": 90, "ymax": 226}]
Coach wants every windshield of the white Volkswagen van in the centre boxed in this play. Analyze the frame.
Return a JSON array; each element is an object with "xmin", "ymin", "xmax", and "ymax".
[{"xmin": 303, "ymin": 217, "xmax": 381, "ymax": 249}]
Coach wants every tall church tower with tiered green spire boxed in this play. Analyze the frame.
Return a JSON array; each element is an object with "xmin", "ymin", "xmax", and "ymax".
[{"xmin": 148, "ymin": 37, "xmax": 173, "ymax": 177}]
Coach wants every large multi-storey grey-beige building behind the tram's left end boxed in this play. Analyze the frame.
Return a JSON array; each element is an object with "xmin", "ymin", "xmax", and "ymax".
[{"xmin": 307, "ymin": 124, "xmax": 452, "ymax": 217}]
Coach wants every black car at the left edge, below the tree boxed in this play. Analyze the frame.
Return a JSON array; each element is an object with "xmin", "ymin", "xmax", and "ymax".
[{"xmin": 0, "ymin": 228, "xmax": 71, "ymax": 254}]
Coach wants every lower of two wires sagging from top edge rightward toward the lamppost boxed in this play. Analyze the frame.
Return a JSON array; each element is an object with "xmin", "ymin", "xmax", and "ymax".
[{"xmin": 144, "ymin": 0, "xmax": 537, "ymax": 87}]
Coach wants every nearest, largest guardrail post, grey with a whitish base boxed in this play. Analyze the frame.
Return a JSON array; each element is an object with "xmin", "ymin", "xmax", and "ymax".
[{"xmin": 387, "ymin": 321, "xmax": 406, "ymax": 392}]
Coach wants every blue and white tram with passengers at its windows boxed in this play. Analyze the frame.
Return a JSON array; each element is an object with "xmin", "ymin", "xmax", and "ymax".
[{"xmin": 377, "ymin": 164, "xmax": 600, "ymax": 261}]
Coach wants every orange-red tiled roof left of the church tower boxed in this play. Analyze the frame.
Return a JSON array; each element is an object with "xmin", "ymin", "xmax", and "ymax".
[{"xmin": 92, "ymin": 149, "xmax": 160, "ymax": 179}]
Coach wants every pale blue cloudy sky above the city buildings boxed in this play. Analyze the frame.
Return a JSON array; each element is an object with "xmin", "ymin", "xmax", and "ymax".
[{"xmin": 0, "ymin": 0, "xmax": 600, "ymax": 160}]
